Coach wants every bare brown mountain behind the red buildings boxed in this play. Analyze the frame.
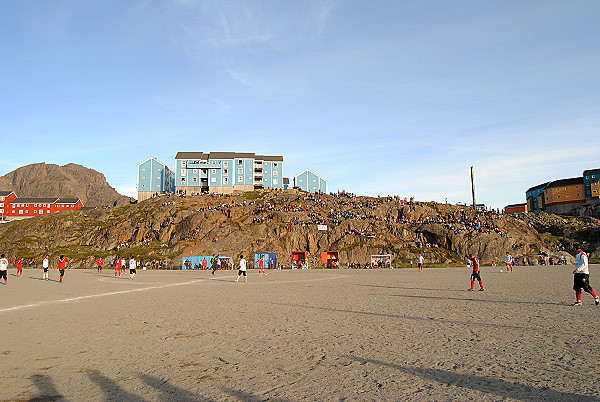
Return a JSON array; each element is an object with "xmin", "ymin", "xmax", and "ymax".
[{"xmin": 0, "ymin": 163, "xmax": 130, "ymax": 206}]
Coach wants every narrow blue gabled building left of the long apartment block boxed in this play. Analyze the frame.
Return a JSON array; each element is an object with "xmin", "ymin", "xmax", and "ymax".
[{"xmin": 137, "ymin": 157, "xmax": 175, "ymax": 201}]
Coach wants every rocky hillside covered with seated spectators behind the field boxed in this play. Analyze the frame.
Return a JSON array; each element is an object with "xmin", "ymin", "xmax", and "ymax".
[{"xmin": 0, "ymin": 190, "xmax": 600, "ymax": 267}]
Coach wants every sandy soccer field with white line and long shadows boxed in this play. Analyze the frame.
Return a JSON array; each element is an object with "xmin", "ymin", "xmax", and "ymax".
[{"xmin": 0, "ymin": 266, "xmax": 600, "ymax": 401}]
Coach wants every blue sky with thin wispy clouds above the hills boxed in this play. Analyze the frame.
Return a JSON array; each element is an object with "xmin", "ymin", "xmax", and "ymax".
[{"xmin": 0, "ymin": 0, "xmax": 600, "ymax": 208}]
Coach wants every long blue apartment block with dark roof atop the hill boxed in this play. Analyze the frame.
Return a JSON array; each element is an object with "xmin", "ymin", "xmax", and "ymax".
[{"xmin": 175, "ymin": 152, "xmax": 283, "ymax": 194}]
